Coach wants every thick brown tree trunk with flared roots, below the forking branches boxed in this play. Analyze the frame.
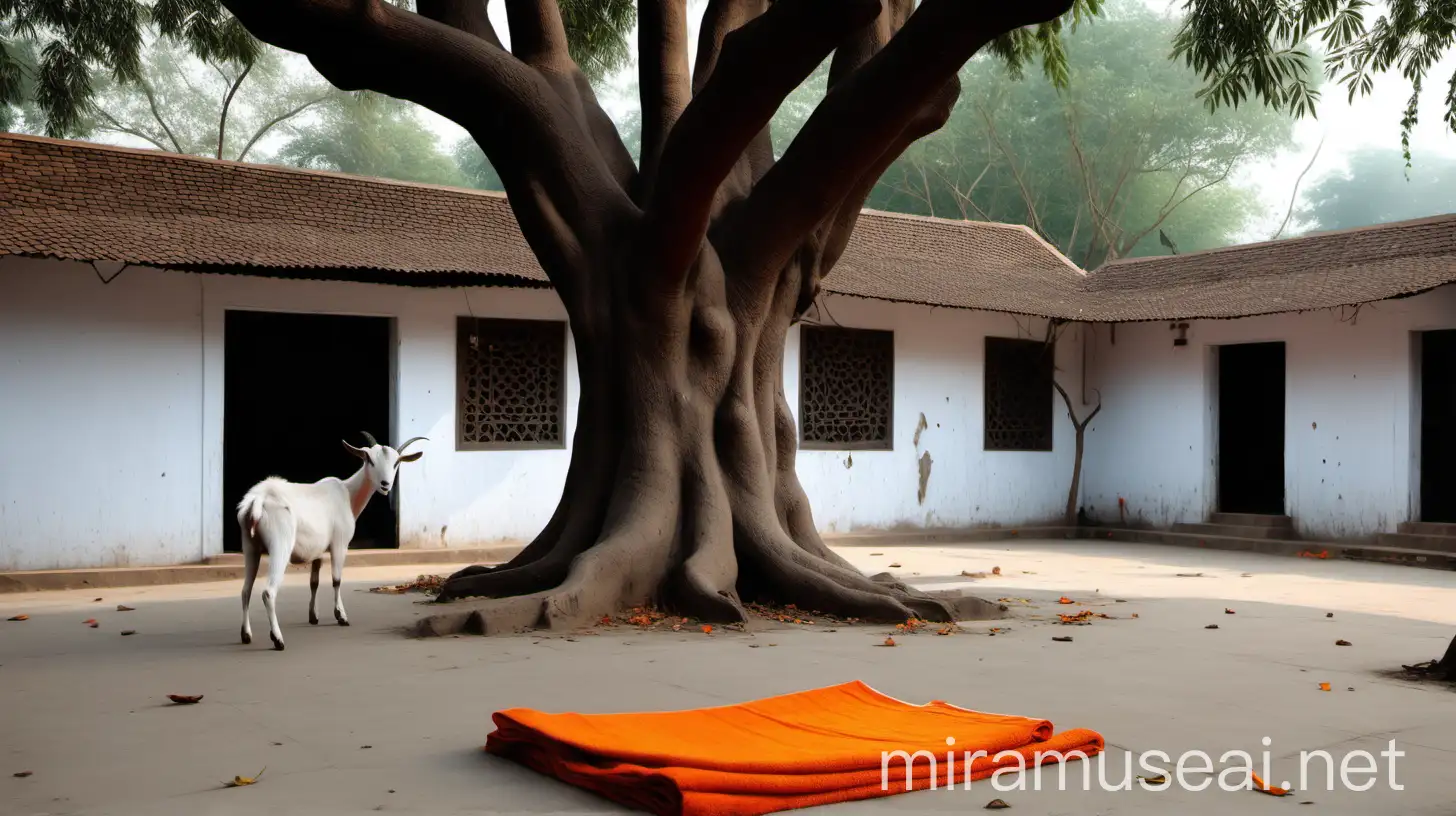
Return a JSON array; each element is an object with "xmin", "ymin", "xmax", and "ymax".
[{"xmin": 419, "ymin": 249, "xmax": 954, "ymax": 635}]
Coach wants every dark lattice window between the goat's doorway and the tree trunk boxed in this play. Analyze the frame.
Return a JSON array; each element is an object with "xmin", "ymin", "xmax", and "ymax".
[{"xmin": 456, "ymin": 318, "xmax": 566, "ymax": 450}]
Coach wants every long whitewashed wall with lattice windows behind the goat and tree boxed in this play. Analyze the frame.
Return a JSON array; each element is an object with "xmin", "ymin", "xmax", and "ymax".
[{"xmin": 0, "ymin": 258, "xmax": 1080, "ymax": 570}]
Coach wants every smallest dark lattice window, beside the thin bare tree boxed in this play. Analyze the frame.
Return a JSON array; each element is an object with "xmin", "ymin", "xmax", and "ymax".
[{"xmin": 986, "ymin": 337, "xmax": 1056, "ymax": 450}]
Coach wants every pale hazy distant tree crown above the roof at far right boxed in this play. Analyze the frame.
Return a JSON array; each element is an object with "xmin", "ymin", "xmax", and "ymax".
[{"xmin": 1299, "ymin": 147, "xmax": 1456, "ymax": 230}]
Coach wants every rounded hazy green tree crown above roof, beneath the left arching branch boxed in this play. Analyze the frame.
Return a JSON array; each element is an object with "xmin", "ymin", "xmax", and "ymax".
[{"xmin": 277, "ymin": 93, "xmax": 466, "ymax": 187}]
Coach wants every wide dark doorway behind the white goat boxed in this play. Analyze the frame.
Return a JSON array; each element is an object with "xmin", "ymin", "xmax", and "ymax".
[{"xmin": 223, "ymin": 312, "xmax": 399, "ymax": 552}]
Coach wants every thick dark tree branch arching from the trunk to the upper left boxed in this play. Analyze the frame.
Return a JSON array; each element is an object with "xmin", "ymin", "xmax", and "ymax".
[{"xmin": 223, "ymin": 0, "xmax": 632, "ymax": 300}]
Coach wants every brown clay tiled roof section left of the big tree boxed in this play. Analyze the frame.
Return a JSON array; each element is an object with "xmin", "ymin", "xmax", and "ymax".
[{"xmin": 0, "ymin": 136, "xmax": 546, "ymax": 286}]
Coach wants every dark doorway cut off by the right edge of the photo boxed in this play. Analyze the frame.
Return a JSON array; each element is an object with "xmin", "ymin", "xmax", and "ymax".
[{"xmin": 1421, "ymin": 329, "xmax": 1456, "ymax": 525}]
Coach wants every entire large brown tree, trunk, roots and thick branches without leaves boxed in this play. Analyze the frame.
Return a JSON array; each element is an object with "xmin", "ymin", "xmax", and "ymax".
[{"xmin": 224, "ymin": 0, "xmax": 1070, "ymax": 634}]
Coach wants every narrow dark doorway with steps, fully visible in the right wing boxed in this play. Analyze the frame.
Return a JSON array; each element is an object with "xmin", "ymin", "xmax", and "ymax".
[{"xmin": 1219, "ymin": 342, "xmax": 1284, "ymax": 516}]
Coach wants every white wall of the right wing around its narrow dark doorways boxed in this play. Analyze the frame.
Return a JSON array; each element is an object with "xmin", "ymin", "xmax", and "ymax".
[{"xmin": 1083, "ymin": 287, "xmax": 1456, "ymax": 539}]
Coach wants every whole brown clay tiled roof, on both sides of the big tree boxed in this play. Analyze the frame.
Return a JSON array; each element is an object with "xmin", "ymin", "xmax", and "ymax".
[{"xmin": 0, "ymin": 136, "xmax": 1456, "ymax": 322}]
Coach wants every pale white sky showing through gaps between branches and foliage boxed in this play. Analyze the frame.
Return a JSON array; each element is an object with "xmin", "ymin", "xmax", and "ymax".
[{"xmin": 407, "ymin": 0, "xmax": 1456, "ymax": 240}]
